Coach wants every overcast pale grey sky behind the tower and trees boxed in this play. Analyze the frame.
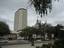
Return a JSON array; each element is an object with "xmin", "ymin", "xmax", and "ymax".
[{"xmin": 0, "ymin": 0, "xmax": 64, "ymax": 30}]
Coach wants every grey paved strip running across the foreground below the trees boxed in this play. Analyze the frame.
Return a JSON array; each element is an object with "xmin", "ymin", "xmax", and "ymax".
[{"xmin": 0, "ymin": 40, "xmax": 54, "ymax": 46}]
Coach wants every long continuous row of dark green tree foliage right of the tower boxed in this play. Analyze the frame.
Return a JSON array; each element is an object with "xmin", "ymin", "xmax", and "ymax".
[{"xmin": 20, "ymin": 24, "xmax": 64, "ymax": 39}]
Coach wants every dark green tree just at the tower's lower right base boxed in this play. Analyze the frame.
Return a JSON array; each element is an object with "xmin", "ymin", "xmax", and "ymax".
[{"xmin": 20, "ymin": 27, "xmax": 36, "ymax": 40}]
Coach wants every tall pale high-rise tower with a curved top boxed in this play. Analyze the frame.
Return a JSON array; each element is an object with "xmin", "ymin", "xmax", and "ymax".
[{"xmin": 14, "ymin": 8, "xmax": 27, "ymax": 31}]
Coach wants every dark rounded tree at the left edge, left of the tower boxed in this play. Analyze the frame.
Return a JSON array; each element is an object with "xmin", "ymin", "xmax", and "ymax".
[{"xmin": 0, "ymin": 21, "xmax": 10, "ymax": 36}]
